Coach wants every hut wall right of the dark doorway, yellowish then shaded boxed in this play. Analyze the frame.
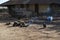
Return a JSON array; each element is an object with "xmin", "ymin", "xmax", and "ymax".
[{"xmin": 39, "ymin": 5, "xmax": 60, "ymax": 16}]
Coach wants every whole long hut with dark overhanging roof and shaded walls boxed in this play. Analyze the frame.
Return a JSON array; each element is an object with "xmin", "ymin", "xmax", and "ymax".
[{"xmin": 0, "ymin": 0, "xmax": 60, "ymax": 17}]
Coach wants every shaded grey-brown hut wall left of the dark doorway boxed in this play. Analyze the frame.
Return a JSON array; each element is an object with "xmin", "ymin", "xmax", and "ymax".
[{"xmin": 9, "ymin": 4, "xmax": 35, "ymax": 17}]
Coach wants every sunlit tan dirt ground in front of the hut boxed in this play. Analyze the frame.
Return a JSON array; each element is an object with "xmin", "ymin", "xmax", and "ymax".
[{"xmin": 0, "ymin": 23, "xmax": 60, "ymax": 40}]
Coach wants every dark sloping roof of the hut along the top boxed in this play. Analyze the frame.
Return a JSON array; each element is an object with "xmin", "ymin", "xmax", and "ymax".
[{"xmin": 1, "ymin": 0, "xmax": 60, "ymax": 5}]
